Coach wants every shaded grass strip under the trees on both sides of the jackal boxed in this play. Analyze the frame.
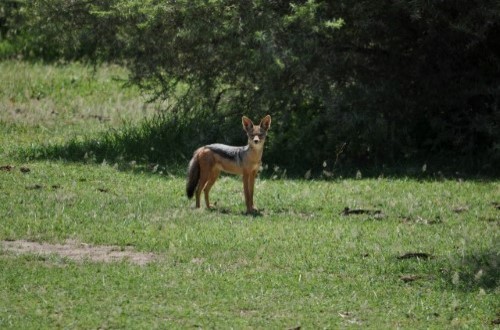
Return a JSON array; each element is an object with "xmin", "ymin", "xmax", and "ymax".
[{"xmin": 18, "ymin": 112, "xmax": 500, "ymax": 180}]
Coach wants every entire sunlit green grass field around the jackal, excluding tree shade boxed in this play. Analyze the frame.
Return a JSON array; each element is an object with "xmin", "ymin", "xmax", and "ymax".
[{"xmin": 0, "ymin": 61, "xmax": 500, "ymax": 329}]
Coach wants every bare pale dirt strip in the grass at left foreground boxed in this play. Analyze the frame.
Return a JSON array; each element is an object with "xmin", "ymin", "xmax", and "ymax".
[{"xmin": 0, "ymin": 240, "xmax": 158, "ymax": 266}]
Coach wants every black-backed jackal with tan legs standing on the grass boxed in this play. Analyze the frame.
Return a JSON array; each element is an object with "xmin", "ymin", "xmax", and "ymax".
[{"xmin": 186, "ymin": 115, "xmax": 271, "ymax": 213}]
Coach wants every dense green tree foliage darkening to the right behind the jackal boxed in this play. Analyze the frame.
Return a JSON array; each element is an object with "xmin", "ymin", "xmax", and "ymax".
[{"xmin": 3, "ymin": 0, "xmax": 500, "ymax": 173}]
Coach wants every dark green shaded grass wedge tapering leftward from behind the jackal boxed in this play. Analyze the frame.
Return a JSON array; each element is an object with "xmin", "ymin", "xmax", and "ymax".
[{"xmin": 18, "ymin": 114, "xmax": 245, "ymax": 175}]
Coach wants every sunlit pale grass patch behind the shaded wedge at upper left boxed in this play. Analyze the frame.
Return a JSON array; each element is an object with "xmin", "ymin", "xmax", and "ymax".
[{"xmin": 0, "ymin": 61, "xmax": 155, "ymax": 155}]
